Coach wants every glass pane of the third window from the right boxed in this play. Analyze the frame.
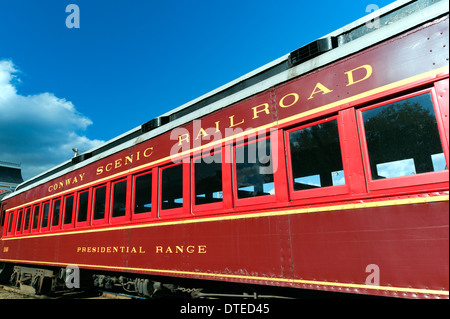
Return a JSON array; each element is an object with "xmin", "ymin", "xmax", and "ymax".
[{"xmin": 236, "ymin": 139, "xmax": 275, "ymax": 198}]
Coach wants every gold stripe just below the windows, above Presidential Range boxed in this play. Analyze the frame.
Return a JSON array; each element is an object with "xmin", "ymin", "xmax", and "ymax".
[{"xmin": 1, "ymin": 195, "xmax": 449, "ymax": 241}]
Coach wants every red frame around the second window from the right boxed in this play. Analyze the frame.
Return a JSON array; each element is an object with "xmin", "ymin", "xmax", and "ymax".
[{"xmin": 285, "ymin": 114, "xmax": 350, "ymax": 200}]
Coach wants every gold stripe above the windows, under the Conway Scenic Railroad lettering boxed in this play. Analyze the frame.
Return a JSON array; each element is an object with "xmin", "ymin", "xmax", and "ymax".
[{"xmin": 7, "ymin": 65, "xmax": 449, "ymax": 212}]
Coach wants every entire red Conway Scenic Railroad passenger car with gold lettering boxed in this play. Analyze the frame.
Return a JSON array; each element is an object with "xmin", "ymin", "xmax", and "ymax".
[{"xmin": 0, "ymin": 0, "xmax": 449, "ymax": 298}]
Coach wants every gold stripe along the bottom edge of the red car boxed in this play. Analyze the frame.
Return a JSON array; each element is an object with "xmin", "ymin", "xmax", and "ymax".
[{"xmin": 0, "ymin": 259, "xmax": 449, "ymax": 296}]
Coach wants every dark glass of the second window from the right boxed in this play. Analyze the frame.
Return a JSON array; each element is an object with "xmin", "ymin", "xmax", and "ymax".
[{"xmin": 289, "ymin": 120, "xmax": 345, "ymax": 191}]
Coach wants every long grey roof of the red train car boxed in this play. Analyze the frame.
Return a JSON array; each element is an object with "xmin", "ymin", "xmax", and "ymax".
[{"xmin": 5, "ymin": 0, "xmax": 449, "ymax": 199}]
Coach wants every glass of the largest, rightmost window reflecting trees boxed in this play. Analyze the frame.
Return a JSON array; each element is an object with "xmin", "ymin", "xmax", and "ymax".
[{"xmin": 362, "ymin": 93, "xmax": 447, "ymax": 180}]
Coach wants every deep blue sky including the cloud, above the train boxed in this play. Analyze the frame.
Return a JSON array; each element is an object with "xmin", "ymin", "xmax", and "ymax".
[{"xmin": 0, "ymin": 0, "xmax": 392, "ymax": 178}]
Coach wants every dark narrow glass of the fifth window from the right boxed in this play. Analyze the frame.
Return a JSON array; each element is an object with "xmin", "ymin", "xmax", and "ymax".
[{"xmin": 161, "ymin": 164, "xmax": 183, "ymax": 209}]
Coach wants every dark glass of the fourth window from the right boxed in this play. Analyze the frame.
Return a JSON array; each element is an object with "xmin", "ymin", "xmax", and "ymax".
[{"xmin": 194, "ymin": 155, "xmax": 223, "ymax": 205}]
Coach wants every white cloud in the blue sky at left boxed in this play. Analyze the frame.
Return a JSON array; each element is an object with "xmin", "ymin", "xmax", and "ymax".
[{"xmin": 0, "ymin": 60, "xmax": 103, "ymax": 179}]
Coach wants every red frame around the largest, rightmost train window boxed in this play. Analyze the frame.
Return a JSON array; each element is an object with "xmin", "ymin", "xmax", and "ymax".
[{"xmin": 356, "ymin": 87, "xmax": 448, "ymax": 191}]
